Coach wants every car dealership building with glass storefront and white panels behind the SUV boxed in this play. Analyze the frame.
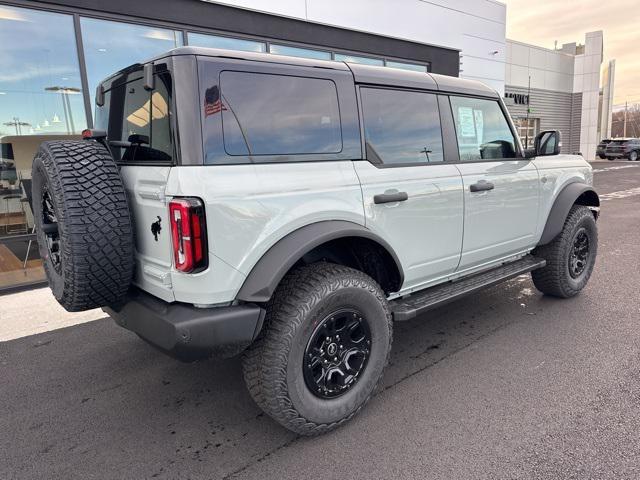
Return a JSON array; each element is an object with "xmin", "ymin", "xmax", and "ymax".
[{"xmin": 0, "ymin": 0, "xmax": 614, "ymax": 291}]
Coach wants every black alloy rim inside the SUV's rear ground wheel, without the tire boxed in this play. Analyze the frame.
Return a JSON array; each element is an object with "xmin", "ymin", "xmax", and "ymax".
[{"xmin": 302, "ymin": 308, "xmax": 371, "ymax": 398}]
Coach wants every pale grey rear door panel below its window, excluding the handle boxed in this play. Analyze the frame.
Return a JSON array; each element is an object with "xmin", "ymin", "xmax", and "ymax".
[{"xmin": 355, "ymin": 161, "xmax": 464, "ymax": 291}]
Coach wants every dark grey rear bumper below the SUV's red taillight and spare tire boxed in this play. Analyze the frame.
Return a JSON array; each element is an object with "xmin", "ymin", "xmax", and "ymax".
[{"xmin": 103, "ymin": 290, "xmax": 265, "ymax": 361}]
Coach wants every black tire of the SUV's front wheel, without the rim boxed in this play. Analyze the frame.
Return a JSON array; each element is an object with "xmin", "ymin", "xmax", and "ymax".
[{"xmin": 531, "ymin": 205, "xmax": 598, "ymax": 298}]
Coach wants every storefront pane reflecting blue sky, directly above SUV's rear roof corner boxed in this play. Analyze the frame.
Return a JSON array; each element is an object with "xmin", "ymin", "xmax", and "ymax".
[{"xmin": 80, "ymin": 17, "xmax": 182, "ymax": 105}]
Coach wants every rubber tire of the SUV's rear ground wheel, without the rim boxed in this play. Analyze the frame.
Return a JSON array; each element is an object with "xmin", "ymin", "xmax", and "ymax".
[{"xmin": 243, "ymin": 262, "xmax": 392, "ymax": 436}]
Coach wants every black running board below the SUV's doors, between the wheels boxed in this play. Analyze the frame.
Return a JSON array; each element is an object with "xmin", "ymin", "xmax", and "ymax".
[{"xmin": 391, "ymin": 255, "xmax": 547, "ymax": 321}]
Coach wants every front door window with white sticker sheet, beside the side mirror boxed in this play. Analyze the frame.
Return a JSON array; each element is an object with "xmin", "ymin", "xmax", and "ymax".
[{"xmin": 450, "ymin": 97, "xmax": 516, "ymax": 162}]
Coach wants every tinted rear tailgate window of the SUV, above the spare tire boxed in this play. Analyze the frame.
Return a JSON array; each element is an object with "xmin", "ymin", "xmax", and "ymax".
[{"xmin": 101, "ymin": 73, "xmax": 173, "ymax": 162}]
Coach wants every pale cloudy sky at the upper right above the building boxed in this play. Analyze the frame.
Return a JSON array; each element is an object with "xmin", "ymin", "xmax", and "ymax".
[{"xmin": 501, "ymin": 0, "xmax": 640, "ymax": 104}]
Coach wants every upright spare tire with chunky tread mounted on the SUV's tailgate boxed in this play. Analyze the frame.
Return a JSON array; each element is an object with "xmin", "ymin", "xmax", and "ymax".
[{"xmin": 32, "ymin": 140, "xmax": 134, "ymax": 312}]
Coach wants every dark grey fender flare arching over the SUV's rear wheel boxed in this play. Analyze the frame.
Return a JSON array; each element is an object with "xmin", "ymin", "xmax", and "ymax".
[{"xmin": 236, "ymin": 220, "xmax": 404, "ymax": 303}]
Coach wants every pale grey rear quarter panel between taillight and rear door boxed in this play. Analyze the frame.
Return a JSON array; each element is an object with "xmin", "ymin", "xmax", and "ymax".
[{"xmin": 166, "ymin": 161, "xmax": 364, "ymax": 304}]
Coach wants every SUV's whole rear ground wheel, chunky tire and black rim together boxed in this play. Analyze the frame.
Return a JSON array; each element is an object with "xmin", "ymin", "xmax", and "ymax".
[{"xmin": 243, "ymin": 263, "xmax": 392, "ymax": 435}]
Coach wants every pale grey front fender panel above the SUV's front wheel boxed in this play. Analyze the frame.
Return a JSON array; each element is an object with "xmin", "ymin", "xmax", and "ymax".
[{"xmin": 533, "ymin": 155, "xmax": 593, "ymax": 244}]
